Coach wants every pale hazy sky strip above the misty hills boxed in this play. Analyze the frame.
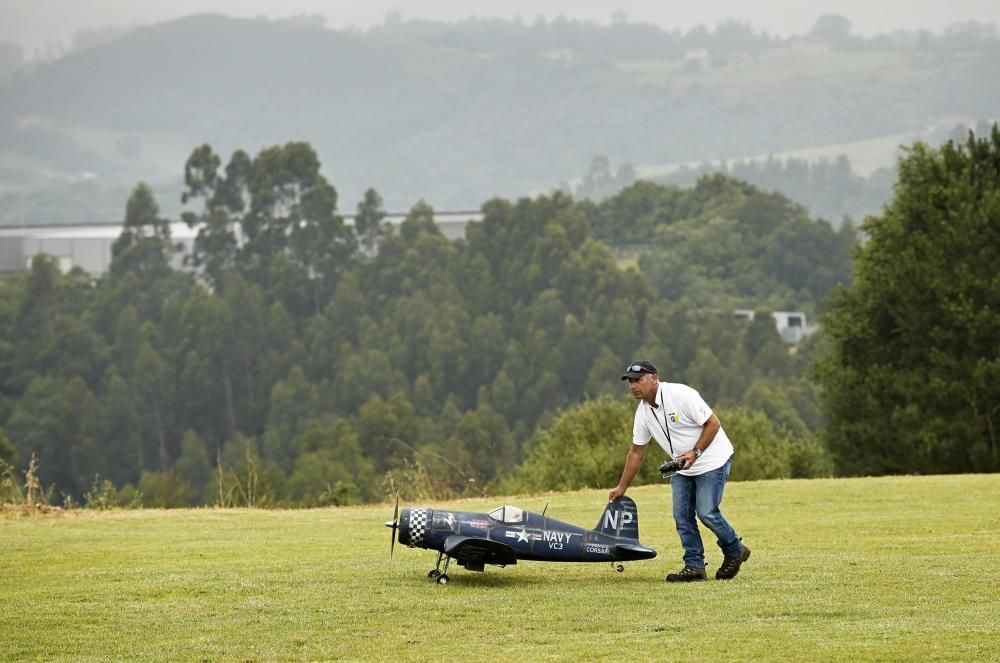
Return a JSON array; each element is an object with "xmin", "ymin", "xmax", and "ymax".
[{"xmin": 0, "ymin": 0, "xmax": 1000, "ymax": 56}]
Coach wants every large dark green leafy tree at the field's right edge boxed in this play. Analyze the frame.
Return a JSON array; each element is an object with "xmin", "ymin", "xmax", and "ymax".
[{"xmin": 817, "ymin": 125, "xmax": 1000, "ymax": 474}]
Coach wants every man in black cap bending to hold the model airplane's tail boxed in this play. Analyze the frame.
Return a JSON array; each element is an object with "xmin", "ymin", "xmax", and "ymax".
[{"xmin": 608, "ymin": 361, "xmax": 750, "ymax": 582}]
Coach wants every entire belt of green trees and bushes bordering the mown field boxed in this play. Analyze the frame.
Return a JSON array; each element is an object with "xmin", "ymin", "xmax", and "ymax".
[{"xmin": 7, "ymin": 130, "xmax": 1000, "ymax": 506}]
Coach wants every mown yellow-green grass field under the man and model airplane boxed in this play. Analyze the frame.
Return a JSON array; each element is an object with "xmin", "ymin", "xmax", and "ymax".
[{"xmin": 0, "ymin": 475, "xmax": 1000, "ymax": 661}]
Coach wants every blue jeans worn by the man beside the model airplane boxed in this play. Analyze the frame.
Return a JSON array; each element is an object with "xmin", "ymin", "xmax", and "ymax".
[{"xmin": 670, "ymin": 458, "xmax": 743, "ymax": 569}]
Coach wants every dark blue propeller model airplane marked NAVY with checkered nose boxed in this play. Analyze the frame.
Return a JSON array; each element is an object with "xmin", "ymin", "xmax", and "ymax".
[{"xmin": 385, "ymin": 496, "xmax": 656, "ymax": 585}]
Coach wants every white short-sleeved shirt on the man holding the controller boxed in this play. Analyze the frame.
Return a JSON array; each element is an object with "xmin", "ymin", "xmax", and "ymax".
[{"xmin": 632, "ymin": 382, "xmax": 733, "ymax": 476}]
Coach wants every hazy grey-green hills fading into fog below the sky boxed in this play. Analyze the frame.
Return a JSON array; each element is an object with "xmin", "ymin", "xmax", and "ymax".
[{"xmin": 0, "ymin": 10, "xmax": 1000, "ymax": 223}]
